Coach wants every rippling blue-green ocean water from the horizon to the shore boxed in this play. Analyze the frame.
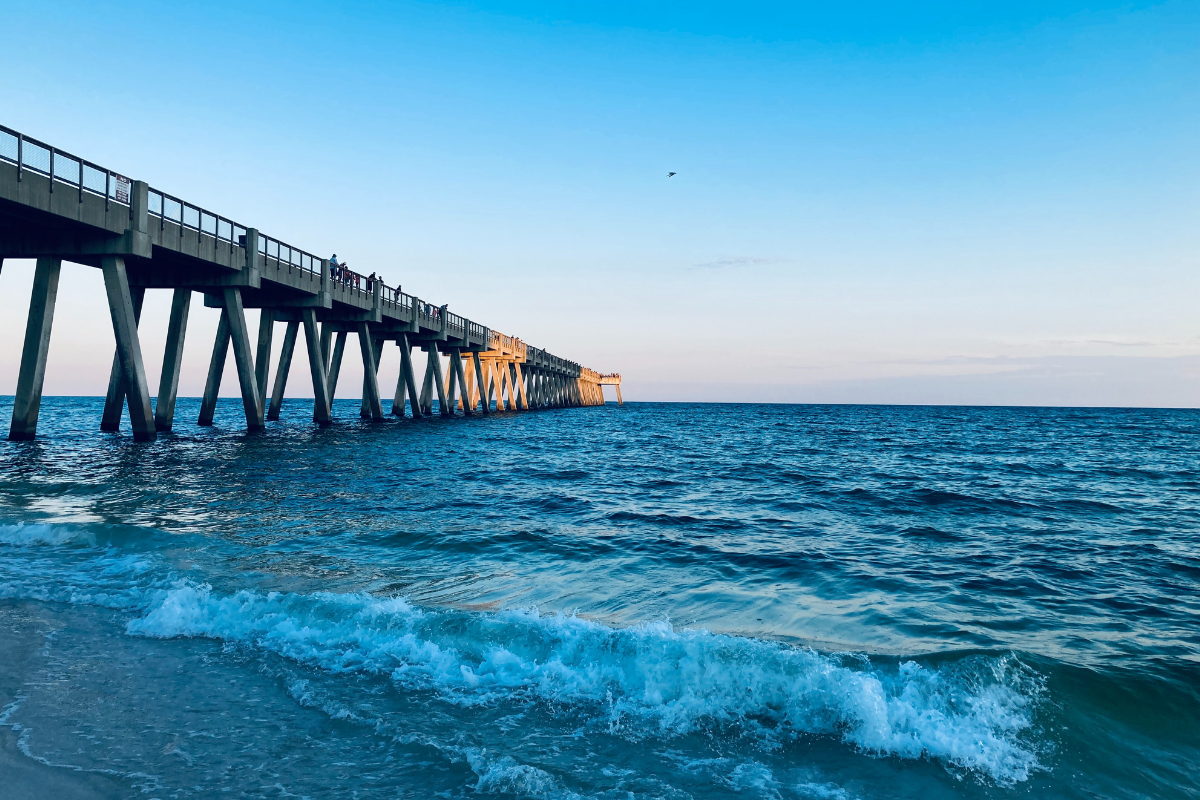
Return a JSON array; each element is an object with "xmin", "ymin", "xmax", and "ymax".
[{"xmin": 0, "ymin": 398, "xmax": 1200, "ymax": 800}]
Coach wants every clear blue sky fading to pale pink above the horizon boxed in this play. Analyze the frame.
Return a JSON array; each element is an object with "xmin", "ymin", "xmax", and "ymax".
[{"xmin": 0, "ymin": 1, "xmax": 1200, "ymax": 405}]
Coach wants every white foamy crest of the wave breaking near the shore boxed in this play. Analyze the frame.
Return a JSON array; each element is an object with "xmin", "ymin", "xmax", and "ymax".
[{"xmin": 127, "ymin": 583, "xmax": 1039, "ymax": 787}]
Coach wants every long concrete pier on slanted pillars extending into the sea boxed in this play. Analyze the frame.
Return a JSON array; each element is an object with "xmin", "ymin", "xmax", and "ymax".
[{"xmin": 0, "ymin": 126, "xmax": 622, "ymax": 440}]
